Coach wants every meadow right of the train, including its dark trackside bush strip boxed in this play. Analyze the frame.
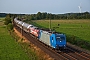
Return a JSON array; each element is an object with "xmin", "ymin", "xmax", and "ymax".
[{"xmin": 28, "ymin": 19, "xmax": 90, "ymax": 49}]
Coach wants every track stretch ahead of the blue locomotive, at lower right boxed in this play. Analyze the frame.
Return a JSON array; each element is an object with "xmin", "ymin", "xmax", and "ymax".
[{"xmin": 65, "ymin": 46, "xmax": 90, "ymax": 60}]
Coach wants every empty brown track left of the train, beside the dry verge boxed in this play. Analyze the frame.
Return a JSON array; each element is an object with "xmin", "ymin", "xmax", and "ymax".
[{"xmin": 16, "ymin": 27, "xmax": 66, "ymax": 60}]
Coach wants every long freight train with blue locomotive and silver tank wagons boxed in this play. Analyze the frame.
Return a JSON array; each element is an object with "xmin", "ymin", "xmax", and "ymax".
[{"xmin": 14, "ymin": 18, "xmax": 66, "ymax": 49}]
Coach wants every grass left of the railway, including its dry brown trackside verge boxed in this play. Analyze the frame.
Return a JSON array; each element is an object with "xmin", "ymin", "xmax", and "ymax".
[{"xmin": 0, "ymin": 18, "xmax": 44, "ymax": 60}]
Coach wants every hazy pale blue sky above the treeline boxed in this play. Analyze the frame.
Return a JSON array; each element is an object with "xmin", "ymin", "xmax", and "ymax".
[{"xmin": 0, "ymin": 0, "xmax": 90, "ymax": 14}]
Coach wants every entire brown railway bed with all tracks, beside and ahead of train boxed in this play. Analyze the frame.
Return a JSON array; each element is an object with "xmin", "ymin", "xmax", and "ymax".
[{"xmin": 15, "ymin": 27, "xmax": 90, "ymax": 60}]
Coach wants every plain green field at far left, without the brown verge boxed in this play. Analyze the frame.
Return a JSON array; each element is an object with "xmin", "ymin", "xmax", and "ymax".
[{"xmin": 0, "ymin": 18, "xmax": 29, "ymax": 60}]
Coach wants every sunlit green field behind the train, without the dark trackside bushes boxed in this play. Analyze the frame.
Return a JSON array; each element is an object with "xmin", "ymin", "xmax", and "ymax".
[{"xmin": 31, "ymin": 20, "xmax": 90, "ymax": 41}]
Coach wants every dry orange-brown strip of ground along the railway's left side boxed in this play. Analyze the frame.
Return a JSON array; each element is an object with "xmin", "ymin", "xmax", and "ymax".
[{"xmin": 14, "ymin": 28, "xmax": 54, "ymax": 60}]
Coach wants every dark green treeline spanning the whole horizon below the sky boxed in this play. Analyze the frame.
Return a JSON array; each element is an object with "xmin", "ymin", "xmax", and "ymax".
[{"xmin": 0, "ymin": 12, "xmax": 90, "ymax": 20}]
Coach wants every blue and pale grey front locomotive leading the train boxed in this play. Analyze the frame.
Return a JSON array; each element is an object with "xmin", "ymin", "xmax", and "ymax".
[{"xmin": 39, "ymin": 30, "xmax": 66, "ymax": 49}]
